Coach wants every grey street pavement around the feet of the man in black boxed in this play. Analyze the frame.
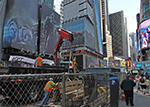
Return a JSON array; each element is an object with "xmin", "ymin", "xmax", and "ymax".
[{"xmin": 119, "ymin": 90, "xmax": 150, "ymax": 107}]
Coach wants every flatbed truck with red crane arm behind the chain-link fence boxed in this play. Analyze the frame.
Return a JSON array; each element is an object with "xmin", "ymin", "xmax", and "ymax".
[{"xmin": 0, "ymin": 29, "xmax": 80, "ymax": 103}]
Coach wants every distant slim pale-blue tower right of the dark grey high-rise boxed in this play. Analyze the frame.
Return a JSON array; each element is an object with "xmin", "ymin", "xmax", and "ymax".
[{"xmin": 129, "ymin": 32, "xmax": 137, "ymax": 61}]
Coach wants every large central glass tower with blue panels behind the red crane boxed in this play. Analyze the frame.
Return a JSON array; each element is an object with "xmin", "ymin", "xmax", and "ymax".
[{"xmin": 61, "ymin": 0, "xmax": 103, "ymax": 69}]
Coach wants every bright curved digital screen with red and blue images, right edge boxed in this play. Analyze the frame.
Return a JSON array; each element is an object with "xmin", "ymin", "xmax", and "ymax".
[{"xmin": 137, "ymin": 19, "xmax": 150, "ymax": 52}]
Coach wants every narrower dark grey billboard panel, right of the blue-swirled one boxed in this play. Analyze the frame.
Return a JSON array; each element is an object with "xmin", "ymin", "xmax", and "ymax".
[{"xmin": 40, "ymin": 4, "xmax": 60, "ymax": 54}]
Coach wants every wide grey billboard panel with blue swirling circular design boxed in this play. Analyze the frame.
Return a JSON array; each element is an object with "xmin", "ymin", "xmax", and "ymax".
[{"xmin": 3, "ymin": 0, "xmax": 38, "ymax": 51}]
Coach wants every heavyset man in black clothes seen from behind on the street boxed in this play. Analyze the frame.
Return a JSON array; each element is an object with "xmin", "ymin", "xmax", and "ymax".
[{"xmin": 121, "ymin": 75, "xmax": 136, "ymax": 106}]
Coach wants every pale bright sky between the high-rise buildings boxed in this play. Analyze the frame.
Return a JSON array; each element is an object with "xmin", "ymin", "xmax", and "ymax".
[{"xmin": 108, "ymin": 0, "xmax": 140, "ymax": 33}]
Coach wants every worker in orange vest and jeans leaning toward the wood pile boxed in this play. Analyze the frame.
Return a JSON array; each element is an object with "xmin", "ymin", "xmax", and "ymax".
[{"xmin": 40, "ymin": 78, "xmax": 57, "ymax": 107}]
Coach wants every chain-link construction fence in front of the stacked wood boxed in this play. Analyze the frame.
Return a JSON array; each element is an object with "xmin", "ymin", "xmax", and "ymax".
[{"xmin": 0, "ymin": 72, "xmax": 125, "ymax": 107}]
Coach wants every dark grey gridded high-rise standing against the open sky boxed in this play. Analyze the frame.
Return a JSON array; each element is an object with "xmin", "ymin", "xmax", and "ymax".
[{"xmin": 109, "ymin": 11, "xmax": 130, "ymax": 59}]
